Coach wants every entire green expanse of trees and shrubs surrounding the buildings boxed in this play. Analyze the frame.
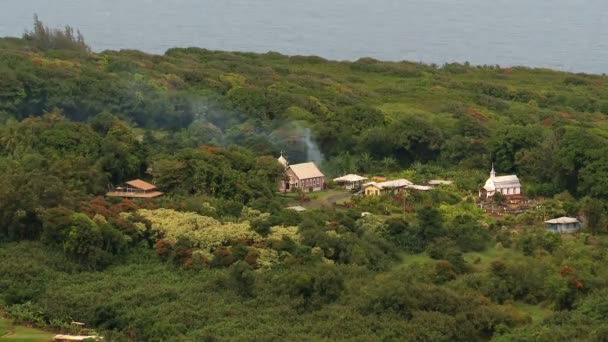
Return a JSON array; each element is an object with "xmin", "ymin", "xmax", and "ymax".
[{"xmin": 0, "ymin": 19, "xmax": 608, "ymax": 341}]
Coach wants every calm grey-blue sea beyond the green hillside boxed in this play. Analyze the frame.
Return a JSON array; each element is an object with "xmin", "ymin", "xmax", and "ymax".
[{"xmin": 0, "ymin": 0, "xmax": 608, "ymax": 73}]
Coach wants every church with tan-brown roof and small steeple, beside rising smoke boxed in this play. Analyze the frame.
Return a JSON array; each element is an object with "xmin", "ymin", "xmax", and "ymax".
[{"xmin": 278, "ymin": 153, "xmax": 327, "ymax": 192}]
